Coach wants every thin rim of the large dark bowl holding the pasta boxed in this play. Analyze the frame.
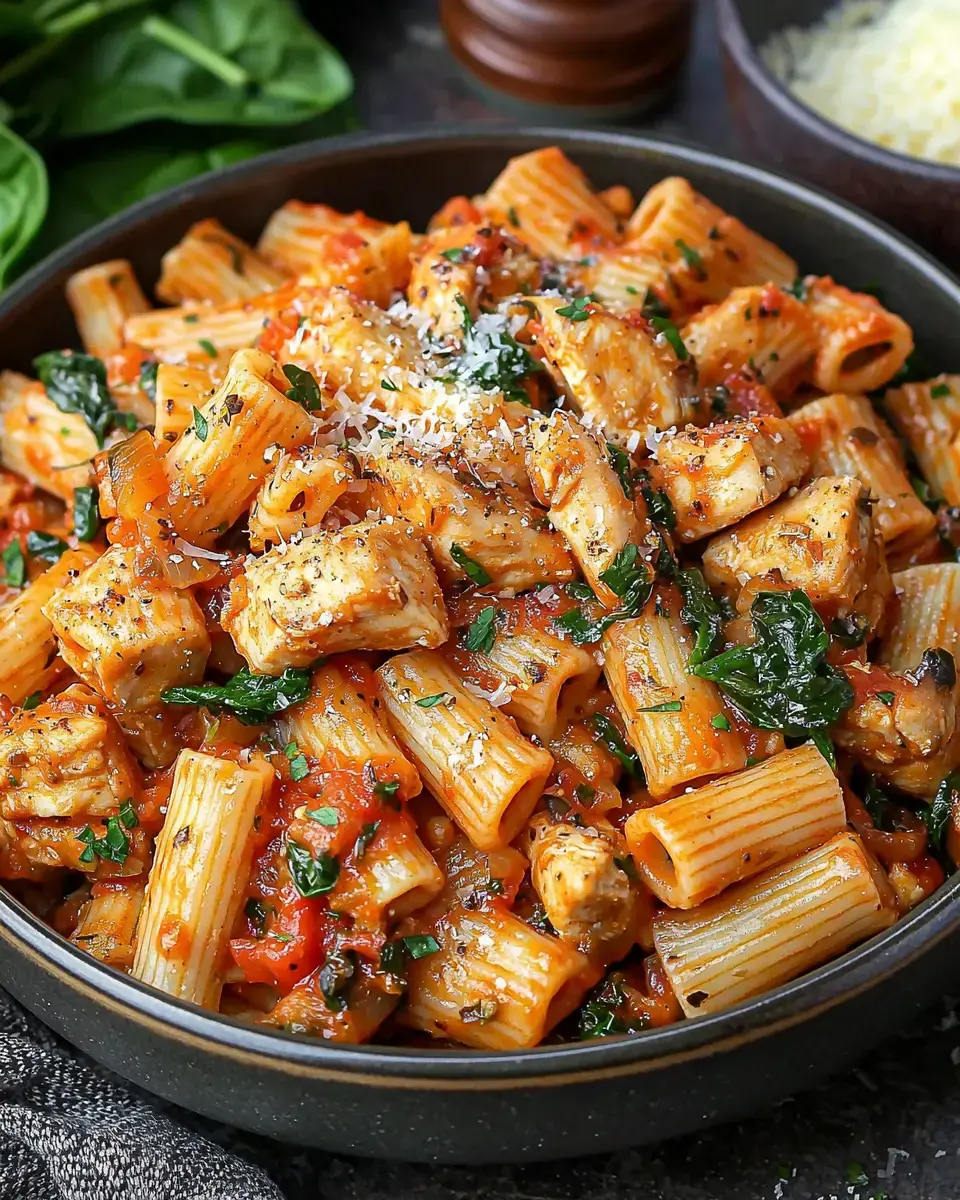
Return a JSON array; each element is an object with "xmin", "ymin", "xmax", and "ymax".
[{"xmin": 0, "ymin": 125, "xmax": 960, "ymax": 1088}]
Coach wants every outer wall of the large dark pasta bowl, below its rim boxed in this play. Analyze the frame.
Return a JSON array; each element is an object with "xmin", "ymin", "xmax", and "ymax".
[{"xmin": 0, "ymin": 907, "xmax": 960, "ymax": 1164}]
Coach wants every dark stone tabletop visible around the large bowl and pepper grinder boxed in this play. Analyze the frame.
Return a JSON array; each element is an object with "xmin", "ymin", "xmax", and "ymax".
[{"xmin": 204, "ymin": 0, "xmax": 960, "ymax": 1200}]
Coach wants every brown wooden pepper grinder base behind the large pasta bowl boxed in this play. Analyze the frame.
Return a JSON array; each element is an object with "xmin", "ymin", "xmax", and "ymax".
[{"xmin": 440, "ymin": 0, "xmax": 692, "ymax": 118}]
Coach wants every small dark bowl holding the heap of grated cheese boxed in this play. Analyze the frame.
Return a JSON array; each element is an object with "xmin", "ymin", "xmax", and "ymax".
[{"xmin": 716, "ymin": 0, "xmax": 960, "ymax": 269}]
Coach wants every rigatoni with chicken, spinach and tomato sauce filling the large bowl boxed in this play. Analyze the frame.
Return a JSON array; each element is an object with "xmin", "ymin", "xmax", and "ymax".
[{"xmin": 0, "ymin": 148, "xmax": 945, "ymax": 1052}]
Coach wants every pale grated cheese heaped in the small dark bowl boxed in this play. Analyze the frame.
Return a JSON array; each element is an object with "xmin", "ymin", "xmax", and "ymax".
[{"xmin": 761, "ymin": 0, "xmax": 960, "ymax": 166}]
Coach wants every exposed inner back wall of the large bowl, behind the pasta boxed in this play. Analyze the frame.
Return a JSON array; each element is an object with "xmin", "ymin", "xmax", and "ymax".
[{"xmin": 0, "ymin": 126, "xmax": 960, "ymax": 370}]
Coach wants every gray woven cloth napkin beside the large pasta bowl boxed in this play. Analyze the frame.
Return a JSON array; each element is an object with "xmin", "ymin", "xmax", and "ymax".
[{"xmin": 0, "ymin": 991, "xmax": 283, "ymax": 1200}]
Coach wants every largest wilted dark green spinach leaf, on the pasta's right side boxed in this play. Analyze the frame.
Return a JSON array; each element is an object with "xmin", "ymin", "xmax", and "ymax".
[{"xmin": 692, "ymin": 590, "xmax": 853, "ymax": 738}]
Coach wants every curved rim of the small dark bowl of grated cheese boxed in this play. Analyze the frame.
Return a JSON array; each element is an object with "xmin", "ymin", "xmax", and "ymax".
[{"xmin": 716, "ymin": 0, "xmax": 960, "ymax": 184}]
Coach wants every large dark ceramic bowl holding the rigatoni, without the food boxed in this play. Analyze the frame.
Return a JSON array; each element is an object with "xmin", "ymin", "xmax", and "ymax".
[{"xmin": 0, "ymin": 128, "xmax": 960, "ymax": 1163}]
